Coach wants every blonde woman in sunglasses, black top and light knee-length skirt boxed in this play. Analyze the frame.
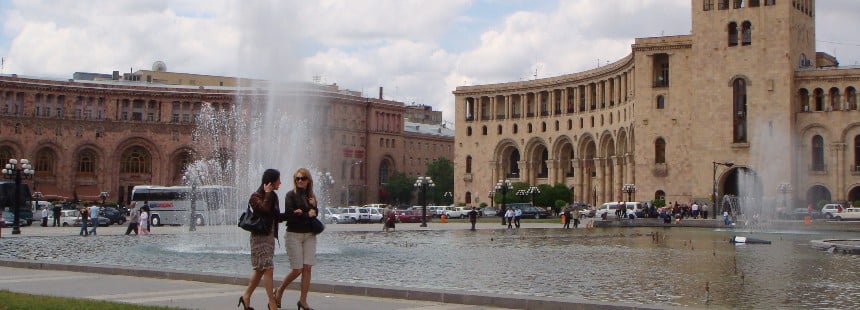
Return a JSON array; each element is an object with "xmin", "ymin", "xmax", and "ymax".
[{"xmin": 275, "ymin": 168, "xmax": 319, "ymax": 310}]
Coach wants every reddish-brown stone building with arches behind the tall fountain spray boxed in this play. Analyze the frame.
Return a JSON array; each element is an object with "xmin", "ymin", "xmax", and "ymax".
[{"xmin": 0, "ymin": 69, "xmax": 453, "ymax": 205}]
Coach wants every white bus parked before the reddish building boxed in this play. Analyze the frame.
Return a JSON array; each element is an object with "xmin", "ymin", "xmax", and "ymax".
[{"xmin": 131, "ymin": 185, "xmax": 236, "ymax": 226}]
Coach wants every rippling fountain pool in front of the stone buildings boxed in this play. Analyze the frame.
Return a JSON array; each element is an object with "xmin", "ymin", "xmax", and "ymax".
[{"xmin": 0, "ymin": 227, "xmax": 860, "ymax": 309}]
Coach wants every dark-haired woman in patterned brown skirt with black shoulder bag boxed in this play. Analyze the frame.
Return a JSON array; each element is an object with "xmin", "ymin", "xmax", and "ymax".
[{"xmin": 236, "ymin": 169, "xmax": 281, "ymax": 309}]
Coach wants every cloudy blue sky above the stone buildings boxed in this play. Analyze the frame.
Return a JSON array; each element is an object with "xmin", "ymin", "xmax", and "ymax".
[{"xmin": 0, "ymin": 0, "xmax": 860, "ymax": 120}]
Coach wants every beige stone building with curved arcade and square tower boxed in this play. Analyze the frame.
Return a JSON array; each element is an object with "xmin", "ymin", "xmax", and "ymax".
[{"xmin": 454, "ymin": 0, "xmax": 860, "ymax": 206}]
